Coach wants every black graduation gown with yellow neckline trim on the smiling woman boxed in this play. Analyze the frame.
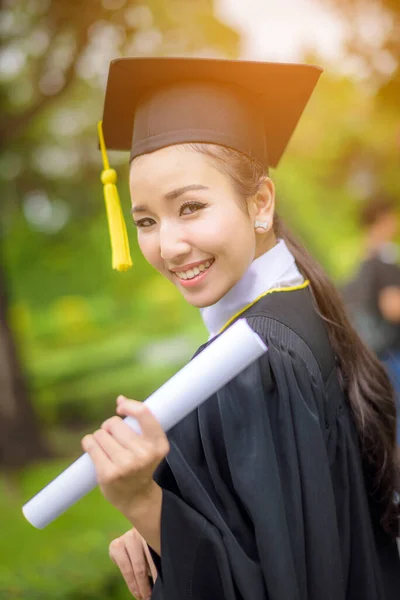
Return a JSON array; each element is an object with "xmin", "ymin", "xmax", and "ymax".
[{"xmin": 152, "ymin": 289, "xmax": 400, "ymax": 600}]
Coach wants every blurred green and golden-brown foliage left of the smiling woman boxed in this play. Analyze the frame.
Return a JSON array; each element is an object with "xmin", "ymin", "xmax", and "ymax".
[{"xmin": 0, "ymin": 0, "xmax": 239, "ymax": 600}]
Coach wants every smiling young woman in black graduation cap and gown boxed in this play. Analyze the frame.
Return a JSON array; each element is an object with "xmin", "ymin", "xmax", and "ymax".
[{"xmin": 82, "ymin": 59, "xmax": 400, "ymax": 600}]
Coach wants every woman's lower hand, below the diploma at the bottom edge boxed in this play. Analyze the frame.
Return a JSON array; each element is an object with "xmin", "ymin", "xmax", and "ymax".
[{"xmin": 109, "ymin": 529, "xmax": 157, "ymax": 600}]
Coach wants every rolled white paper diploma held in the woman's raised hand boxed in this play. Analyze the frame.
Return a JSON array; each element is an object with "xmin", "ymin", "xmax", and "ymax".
[{"xmin": 22, "ymin": 319, "xmax": 267, "ymax": 529}]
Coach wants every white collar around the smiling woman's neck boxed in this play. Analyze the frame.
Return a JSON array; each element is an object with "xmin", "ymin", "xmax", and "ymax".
[{"xmin": 200, "ymin": 240, "xmax": 304, "ymax": 339}]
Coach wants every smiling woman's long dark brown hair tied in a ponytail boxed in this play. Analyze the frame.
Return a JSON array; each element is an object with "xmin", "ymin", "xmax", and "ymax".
[{"xmin": 185, "ymin": 143, "xmax": 399, "ymax": 536}]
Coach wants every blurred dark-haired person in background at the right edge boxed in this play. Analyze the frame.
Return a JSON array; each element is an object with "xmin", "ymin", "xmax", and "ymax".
[{"xmin": 344, "ymin": 195, "xmax": 400, "ymax": 443}]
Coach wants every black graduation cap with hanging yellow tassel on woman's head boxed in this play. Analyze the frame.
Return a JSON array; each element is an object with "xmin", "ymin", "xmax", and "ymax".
[{"xmin": 99, "ymin": 57, "xmax": 322, "ymax": 270}]
